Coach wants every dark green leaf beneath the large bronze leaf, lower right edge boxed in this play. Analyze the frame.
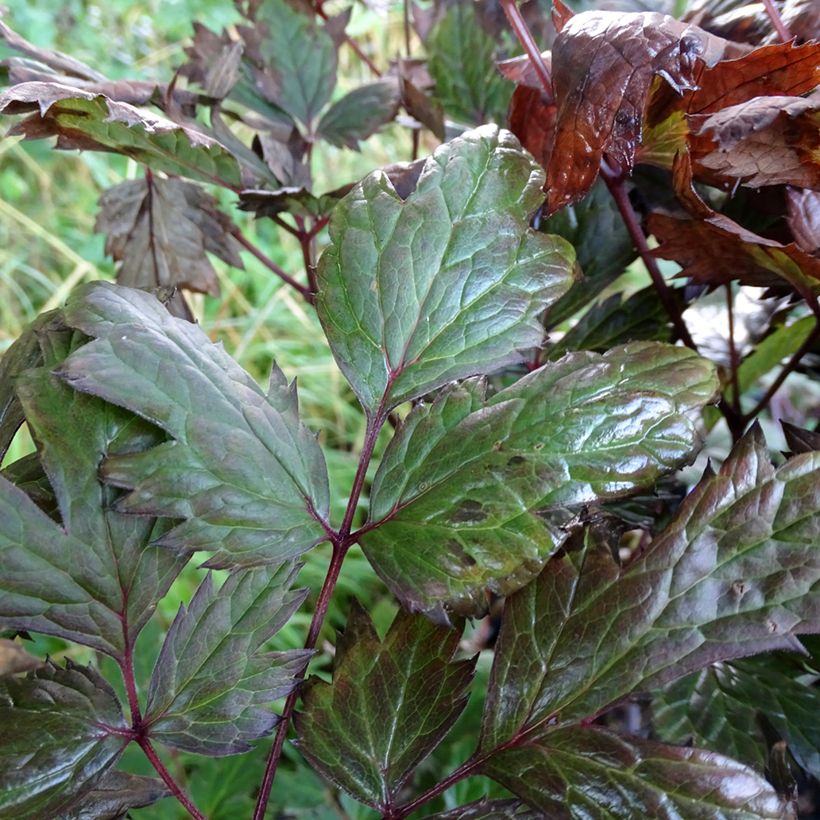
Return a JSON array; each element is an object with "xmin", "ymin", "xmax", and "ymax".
[{"xmin": 652, "ymin": 654, "xmax": 820, "ymax": 777}]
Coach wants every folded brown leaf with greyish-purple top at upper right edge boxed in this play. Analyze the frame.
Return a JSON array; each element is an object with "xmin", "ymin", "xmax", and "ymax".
[{"xmin": 689, "ymin": 93, "xmax": 820, "ymax": 188}]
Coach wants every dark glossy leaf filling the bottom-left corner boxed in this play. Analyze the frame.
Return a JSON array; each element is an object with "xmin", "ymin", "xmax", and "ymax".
[{"xmin": 0, "ymin": 661, "xmax": 129, "ymax": 817}]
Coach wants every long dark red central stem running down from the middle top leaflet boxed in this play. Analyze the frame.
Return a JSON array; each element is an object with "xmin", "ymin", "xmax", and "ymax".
[{"xmin": 253, "ymin": 406, "xmax": 387, "ymax": 820}]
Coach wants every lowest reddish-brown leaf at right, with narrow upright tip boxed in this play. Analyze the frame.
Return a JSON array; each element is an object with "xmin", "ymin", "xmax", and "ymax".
[{"xmin": 648, "ymin": 155, "xmax": 820, "ymax": 310}]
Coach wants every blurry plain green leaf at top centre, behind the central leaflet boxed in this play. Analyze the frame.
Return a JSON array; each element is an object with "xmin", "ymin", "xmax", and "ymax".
[{"xmin": 426, "ymin": 2, "xmax": 514, "ymax": 125}]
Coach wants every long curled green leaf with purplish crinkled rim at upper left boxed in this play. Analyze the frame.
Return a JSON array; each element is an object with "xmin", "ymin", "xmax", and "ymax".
[{"xmin": 0, "ymin": 82, "xmax": 242, "ymax": 187}]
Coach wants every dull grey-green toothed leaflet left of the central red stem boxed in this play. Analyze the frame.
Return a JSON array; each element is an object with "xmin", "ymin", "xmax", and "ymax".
[{"xmin": 60, "ymin": 282, "xmax": 329, "ymax": 568}]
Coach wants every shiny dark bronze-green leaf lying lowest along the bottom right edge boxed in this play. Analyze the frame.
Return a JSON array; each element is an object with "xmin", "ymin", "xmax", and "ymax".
[{"xmin": 482, "ymin": 726, "xmax": 791, "ymax": 820}]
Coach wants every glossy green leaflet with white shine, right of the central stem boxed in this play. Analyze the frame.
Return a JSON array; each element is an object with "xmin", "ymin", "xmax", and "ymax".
[{"xmin": 360, "ymin": 342, "xmax": 717, "ymax": 618}]
